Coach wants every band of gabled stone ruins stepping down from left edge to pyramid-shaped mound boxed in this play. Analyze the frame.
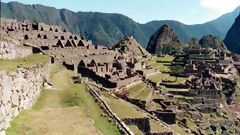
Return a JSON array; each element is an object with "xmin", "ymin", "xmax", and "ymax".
[{"xmin": 1, "ymin": 19, "xmax": 154, "ymax": 88}]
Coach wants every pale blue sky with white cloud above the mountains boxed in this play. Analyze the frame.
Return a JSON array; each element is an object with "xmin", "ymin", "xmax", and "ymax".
[{"xmin": 2, "ymin": 0, "xmax": 240, "ymax": 24}]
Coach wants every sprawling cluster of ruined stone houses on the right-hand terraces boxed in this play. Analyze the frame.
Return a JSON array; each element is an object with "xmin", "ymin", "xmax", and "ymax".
[{"xmin": 148, "ymin": 48, "xmax": 240, "ymax": 127}]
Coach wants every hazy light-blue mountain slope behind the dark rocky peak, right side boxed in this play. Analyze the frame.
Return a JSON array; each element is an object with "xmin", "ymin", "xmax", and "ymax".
[{"xmin": 142, "ymin": 7, "xmax": 240, "ymax": 42}]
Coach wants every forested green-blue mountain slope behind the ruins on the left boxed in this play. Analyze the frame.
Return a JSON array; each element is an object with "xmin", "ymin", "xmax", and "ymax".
[{"xmin": 1, "ymin": 2, "xmax": 148, "ymax": 45}]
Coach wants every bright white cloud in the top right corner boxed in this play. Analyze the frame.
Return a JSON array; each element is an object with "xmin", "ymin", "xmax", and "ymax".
[{"xmin": 200, "ymin": 0, "xmax": 240, "ymax": 14}]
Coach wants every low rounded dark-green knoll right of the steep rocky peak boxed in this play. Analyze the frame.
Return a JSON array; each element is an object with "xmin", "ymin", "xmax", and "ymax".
[{"xmin": 199, "ymin": 35, "xmax": 227, "ymax": 50}]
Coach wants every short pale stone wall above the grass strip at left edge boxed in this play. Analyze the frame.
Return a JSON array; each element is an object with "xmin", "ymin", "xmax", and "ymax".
[{"xmin": 0, "ymin": 36, "xmax": 32, "ymax": 59}]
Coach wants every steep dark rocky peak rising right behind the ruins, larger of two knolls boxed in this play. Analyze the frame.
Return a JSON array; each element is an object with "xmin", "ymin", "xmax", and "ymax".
[{"xmin": 147, "ymin": 25, "xmax": 181, "ymax": 54}]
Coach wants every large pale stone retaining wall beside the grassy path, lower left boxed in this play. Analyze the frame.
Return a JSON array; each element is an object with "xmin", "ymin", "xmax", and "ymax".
[{"xmin": 0, "ymin": 64, "xmax": 50, "ymax": 135}]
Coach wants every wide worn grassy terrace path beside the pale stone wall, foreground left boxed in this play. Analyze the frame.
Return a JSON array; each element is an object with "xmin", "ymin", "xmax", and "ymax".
[{"xmin": 7, "ymin": 66, "xmax": 120, "ymax": 135}]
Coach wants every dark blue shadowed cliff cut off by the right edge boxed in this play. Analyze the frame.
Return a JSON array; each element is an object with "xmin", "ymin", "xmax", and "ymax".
[{"xmin": 224, "ymin": 15, "xmax": 240, "ymax": 54}]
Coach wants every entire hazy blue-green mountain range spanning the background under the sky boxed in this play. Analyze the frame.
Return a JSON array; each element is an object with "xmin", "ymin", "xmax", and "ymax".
[{"xmin": 1, "ymin": 2, "xmax": 240, "ymax": 48}]
